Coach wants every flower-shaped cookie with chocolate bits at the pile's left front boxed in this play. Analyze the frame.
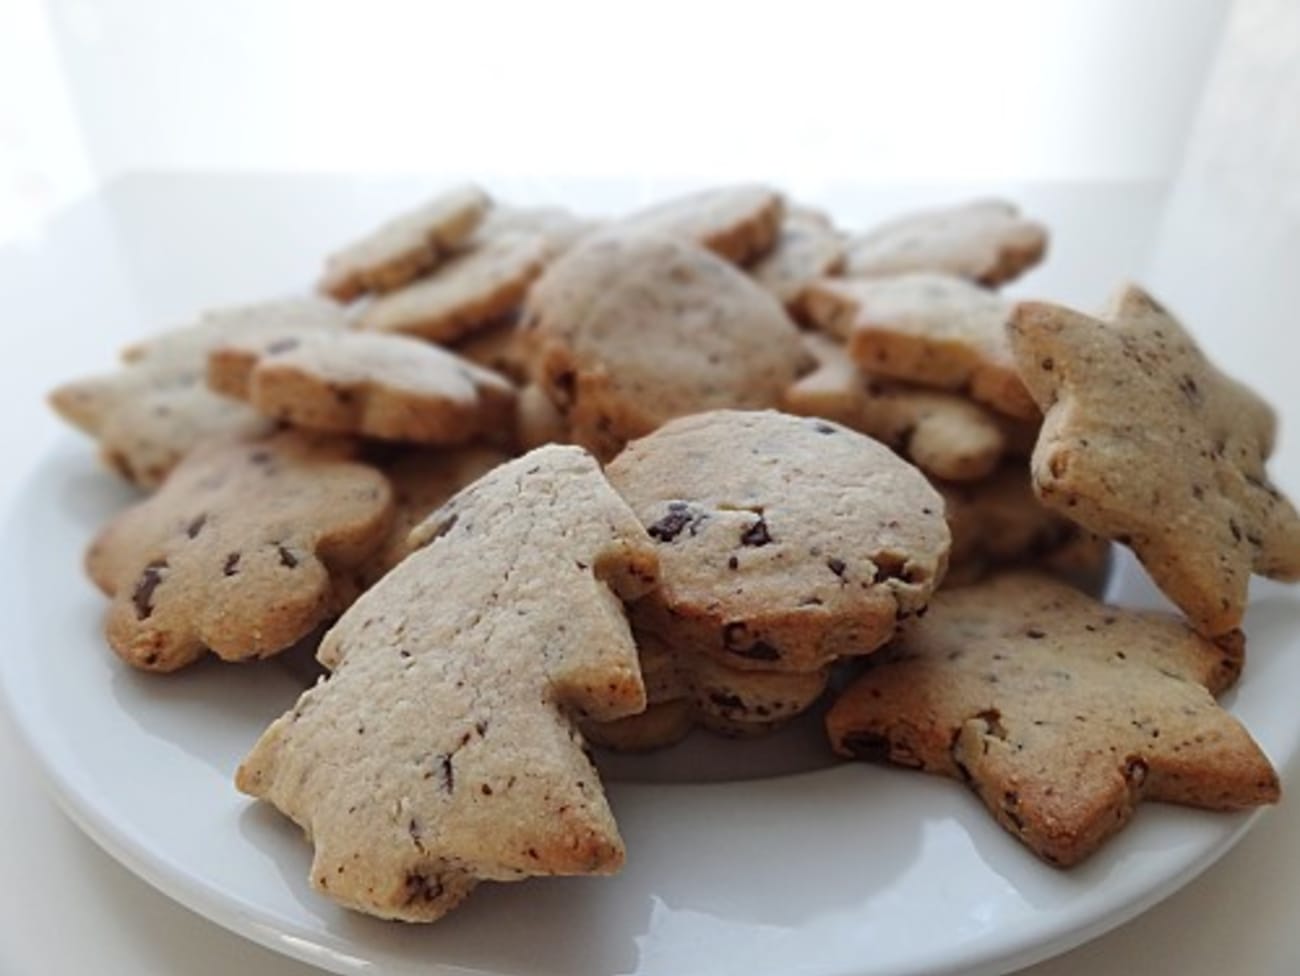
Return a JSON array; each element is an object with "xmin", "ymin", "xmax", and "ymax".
[{"xmin": 86, "ymin": 431, "xmax": 393, "ymax": 671}]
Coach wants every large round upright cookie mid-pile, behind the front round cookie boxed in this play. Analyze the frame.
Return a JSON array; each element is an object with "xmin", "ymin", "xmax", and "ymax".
[{"xmin": 524, "ymin": 234, "xmax": 806, "ymax": 457}]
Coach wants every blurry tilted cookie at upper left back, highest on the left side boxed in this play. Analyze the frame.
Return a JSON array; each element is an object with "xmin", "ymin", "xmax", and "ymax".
[{"xmin": 319, "ymin": 183, "xmax": 491, "ymax": 302}]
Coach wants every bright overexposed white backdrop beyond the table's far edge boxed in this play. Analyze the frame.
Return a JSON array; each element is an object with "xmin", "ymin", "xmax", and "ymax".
[{"xmin": 0, "ymin": 0, "xmax": 1227, "ymax": 243}]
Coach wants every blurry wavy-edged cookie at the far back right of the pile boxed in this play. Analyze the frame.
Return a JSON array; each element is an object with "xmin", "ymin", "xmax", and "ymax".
[{"xmin": 844, "ymin": 200, "xmax": 1048, "ymax": 286}]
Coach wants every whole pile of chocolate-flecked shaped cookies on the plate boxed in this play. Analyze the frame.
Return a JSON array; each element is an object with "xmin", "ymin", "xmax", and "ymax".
[{"xmin": 51, "ymin": 186, "xmax": 1300, "ymax": 921}]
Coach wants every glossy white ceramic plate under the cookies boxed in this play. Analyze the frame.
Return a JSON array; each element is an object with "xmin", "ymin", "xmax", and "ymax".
[{"xmin": 0, "ymin": 438, "xmax": 1300, "ymax": 976}]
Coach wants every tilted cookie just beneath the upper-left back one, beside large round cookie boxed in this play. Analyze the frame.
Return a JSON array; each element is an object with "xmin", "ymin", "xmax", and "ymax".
[{"xmin": 358, "ymin": 234, "xmax": 551, "ymax": 343}]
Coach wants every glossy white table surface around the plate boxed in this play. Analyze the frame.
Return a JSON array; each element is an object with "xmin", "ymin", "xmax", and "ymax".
[{"xmin": 0, "ymin": 174, "xmax": 1300, "ymax": 976}]
